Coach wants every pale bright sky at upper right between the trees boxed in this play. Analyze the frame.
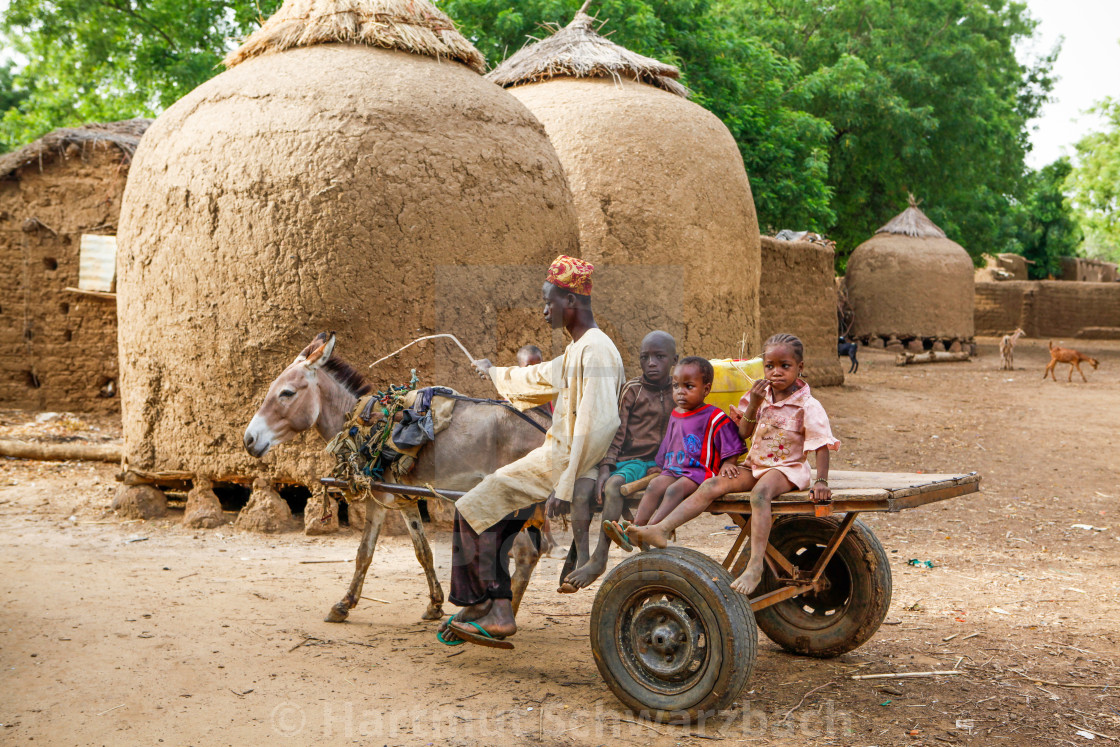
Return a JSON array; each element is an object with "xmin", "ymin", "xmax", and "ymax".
[{"xmin": 1020, "ymin": 0, "xmax": 1120, "ymax": 168}]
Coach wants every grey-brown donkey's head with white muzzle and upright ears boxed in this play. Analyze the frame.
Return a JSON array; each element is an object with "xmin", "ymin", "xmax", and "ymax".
[{"xmin": 244, "ymin": 333, "xmax": 370, "ymax": 457}]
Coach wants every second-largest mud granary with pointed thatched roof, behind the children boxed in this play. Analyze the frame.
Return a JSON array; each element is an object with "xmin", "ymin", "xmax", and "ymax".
[{"xmin": 487, "ymin": 4, "xmax": 759, "ymax": 372}]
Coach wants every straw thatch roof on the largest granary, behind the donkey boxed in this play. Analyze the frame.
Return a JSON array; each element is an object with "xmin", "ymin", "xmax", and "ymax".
[{"xmin": 224, "ymin": 0, "xmax": 486, "ymax": 73}]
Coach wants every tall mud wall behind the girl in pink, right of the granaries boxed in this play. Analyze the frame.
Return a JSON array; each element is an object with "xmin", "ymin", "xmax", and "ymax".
[{"xmin": 758, "ymin": 236, "xmax": 843, "ymax": 386}]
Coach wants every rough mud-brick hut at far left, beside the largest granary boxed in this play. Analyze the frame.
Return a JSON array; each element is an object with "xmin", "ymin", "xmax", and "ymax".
[{"xmin": 0, "ymin": 120, "xmax": 149, "ymax": 412}]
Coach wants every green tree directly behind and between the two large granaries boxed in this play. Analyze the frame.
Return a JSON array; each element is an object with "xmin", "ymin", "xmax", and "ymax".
[{"xmin": 440, "ymin": 0, "xmax": 833, "ymax": 231}]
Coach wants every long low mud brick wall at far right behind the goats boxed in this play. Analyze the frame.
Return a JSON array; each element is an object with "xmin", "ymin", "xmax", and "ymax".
[{"xmin": 976, "ymin": 280, "xmax": 1120, "ymax": 338}]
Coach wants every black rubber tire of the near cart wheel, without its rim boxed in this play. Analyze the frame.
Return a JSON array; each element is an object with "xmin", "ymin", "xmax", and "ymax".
[{"xmin": 591, "ymin": 548, "xmax": 758, "ymax": 723}]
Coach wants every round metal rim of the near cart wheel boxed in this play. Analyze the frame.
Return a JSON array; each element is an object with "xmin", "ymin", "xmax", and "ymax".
[{"xmin": 615, "ymin": 587, "xmax": 711, "ymax": 695}]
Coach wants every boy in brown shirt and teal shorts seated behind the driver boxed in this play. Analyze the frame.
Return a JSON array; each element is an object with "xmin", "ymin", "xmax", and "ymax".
[{"xmin": 560, "ymin": 332, "xmax": 676, "ymax": 594}]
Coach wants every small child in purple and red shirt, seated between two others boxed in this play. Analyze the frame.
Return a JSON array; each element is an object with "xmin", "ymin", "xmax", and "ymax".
[{"xmin": 603, "ymin": 355, "xmax": 745, "ymax": 551}]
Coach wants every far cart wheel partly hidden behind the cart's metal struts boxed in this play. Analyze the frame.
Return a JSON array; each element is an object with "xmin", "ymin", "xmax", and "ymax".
[{"xmin": 755, "ymin": 516, "xmax": 890, "ymax": 659}]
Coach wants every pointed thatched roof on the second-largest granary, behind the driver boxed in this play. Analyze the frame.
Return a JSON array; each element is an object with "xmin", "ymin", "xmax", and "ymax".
[{"xmin": 486, "ymin": 3, "xmax": 689, "ymax": 97}]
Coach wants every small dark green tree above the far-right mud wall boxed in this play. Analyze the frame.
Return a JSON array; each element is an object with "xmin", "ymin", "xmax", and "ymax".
[{"xmin": 1006, "ymin": 158, "xmax": 1084, "ymax": 279}]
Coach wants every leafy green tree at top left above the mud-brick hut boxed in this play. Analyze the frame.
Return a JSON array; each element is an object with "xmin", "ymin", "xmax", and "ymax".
[{"xmin": 0, "ymin": 0, "xmax": 280, "ymax": 147}]
